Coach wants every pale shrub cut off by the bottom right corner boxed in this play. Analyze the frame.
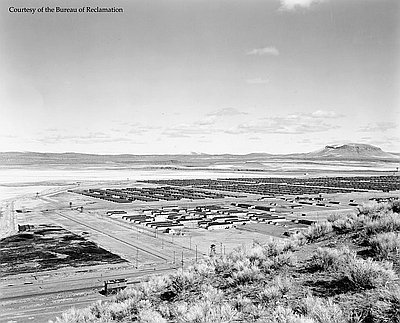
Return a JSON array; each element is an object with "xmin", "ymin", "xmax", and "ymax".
[{"xmin": 371, "ymin": 286, "xmax": 400, "ymax": 323}]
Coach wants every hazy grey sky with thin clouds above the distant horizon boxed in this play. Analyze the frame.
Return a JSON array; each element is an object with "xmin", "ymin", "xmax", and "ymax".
[{"xmin": 0, "ymin": 0, "xmax": 400, "ymax": 154}]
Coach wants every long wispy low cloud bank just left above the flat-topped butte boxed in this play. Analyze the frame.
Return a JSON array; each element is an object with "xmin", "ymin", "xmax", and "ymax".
[{"xmin": 225, "ymin": 110, "xmax": 340, "ymax": 134}]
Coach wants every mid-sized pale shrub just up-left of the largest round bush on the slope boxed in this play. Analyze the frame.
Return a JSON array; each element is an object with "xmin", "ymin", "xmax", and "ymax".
[{"xmin": 310, "ymin": 247, "xmax": 356, "ymax": 272}]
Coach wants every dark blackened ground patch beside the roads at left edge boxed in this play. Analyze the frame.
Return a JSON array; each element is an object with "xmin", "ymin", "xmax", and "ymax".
[{"xmin": 0, "ymin": 224, "xmax": 125, "ymax": 277}]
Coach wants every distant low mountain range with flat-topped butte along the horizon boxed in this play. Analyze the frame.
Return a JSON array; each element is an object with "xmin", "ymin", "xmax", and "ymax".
[{"xmin": 0, "ymin": 143, "xmax": 400, "ymax": 167}]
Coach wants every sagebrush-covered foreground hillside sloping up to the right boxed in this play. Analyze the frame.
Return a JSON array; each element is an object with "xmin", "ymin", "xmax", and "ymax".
[{"xmin": 56, "ymin": 201, "xmax": 400, "ymax": 323}]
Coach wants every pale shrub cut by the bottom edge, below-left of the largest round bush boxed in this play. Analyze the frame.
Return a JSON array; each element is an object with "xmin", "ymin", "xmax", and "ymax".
[{"xmin": 300, "ymin": 296, "xmax": 346, "ymax": 323}]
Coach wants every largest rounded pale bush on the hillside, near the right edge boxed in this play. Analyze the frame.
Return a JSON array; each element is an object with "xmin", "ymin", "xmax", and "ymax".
[{"xmin": 342, "ymin": 258, "xmax": 397, "ymax": 289}]
